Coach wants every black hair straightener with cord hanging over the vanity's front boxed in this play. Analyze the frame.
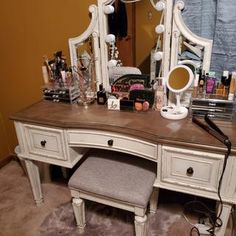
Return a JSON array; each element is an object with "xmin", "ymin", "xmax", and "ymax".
[{"xmin": 190, "ymin": 115, "xmax": 232, "ymax": 236}]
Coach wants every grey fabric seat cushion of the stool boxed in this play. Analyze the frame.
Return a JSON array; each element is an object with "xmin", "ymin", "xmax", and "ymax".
[{"xmin": 68, "ymin": 150, "xmax": 156, "ymax": 208}]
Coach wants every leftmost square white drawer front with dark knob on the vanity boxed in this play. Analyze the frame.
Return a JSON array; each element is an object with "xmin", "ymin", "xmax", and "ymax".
[{"xmin": 24, "ymin": 125, "xmax": 66, "ymax": 160}]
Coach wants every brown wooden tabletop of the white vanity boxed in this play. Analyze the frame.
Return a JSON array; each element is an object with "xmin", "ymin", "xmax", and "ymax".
[{"xmin": 11, "ymin": 101, "xmax": 236, "ymax": 154}]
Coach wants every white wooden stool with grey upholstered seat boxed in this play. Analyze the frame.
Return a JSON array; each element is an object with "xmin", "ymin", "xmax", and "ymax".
[{"xmin": 68, "ymin": 150, "xmax": 157, "ymax": 236}]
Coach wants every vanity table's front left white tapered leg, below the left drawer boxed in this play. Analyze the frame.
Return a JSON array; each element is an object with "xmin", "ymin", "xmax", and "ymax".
[{"xmin": 25, "ymin": 159, "xmax": 43, "ymax": 206}]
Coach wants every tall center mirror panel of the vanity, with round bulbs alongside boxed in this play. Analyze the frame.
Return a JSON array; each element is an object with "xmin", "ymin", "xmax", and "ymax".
[{"xmin": 98, "ymin": 0, "xmax": 164, "ymax": 91}]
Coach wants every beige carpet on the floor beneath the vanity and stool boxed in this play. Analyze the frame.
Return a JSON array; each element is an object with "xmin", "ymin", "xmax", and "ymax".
[{"xmin": 0, "ymin": 161, "xmax": 234, "ymax": 236}]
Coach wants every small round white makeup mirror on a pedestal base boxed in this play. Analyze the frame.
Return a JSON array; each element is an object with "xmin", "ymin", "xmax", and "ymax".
[{"xmin": 161, "ymin": 65, "xmax": 193, "ymax": 120}]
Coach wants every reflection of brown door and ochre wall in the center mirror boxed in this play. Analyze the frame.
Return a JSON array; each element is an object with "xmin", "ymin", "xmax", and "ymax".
[{"xmin": 108, "ymin": 0, "xmax": 161, "ymax": 74}]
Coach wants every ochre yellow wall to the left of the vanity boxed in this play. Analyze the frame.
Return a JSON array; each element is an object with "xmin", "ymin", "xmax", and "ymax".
[{"xmin": 0, "ymin": 0, "xmax": 96, "ymax": 161}]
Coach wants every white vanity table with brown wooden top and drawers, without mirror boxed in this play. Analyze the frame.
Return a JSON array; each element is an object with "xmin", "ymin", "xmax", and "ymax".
[{"xmin": 11, "ymin": 101, "xmax": 236, "ymax": 236}]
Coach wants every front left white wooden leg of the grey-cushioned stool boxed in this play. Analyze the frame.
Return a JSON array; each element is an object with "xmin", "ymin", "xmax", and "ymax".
[{"xmin": 72, "ymin": 198, "xmax": 85, "ymax": 229}]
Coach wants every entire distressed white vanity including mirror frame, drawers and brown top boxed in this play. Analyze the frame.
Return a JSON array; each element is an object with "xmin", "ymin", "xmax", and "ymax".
[{"xmin": 11, "ymin": 0, "xmax": 236, "ymax": 236}]
